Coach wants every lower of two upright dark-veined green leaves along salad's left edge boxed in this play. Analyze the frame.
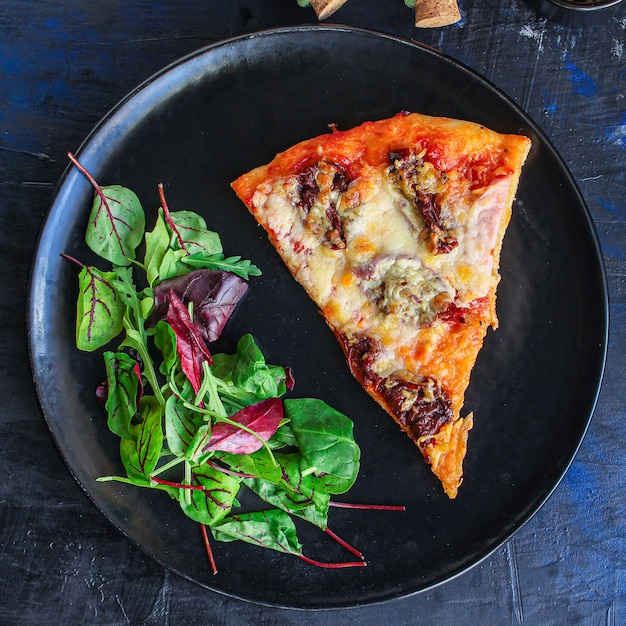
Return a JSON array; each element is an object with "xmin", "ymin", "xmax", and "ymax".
[{"xmin": 120, "ymin": 396, "xmax": 163, "ymax": 484}]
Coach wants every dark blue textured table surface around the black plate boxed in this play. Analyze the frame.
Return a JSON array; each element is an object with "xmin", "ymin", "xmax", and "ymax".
[{"xmin": 0, "ymin": 0, "xmax": 626, "ymax": 625}]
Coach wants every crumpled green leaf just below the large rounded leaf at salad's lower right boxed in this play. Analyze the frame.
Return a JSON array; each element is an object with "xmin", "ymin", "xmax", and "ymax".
[{"xmin": 244, "ymin": 453, "xmax": 330, "ymax": 530}]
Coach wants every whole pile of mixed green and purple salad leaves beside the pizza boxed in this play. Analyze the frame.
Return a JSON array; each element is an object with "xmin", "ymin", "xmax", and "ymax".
[{"xmin": 63, "ymin": 155, "xmax": 403, "ymax": 573}]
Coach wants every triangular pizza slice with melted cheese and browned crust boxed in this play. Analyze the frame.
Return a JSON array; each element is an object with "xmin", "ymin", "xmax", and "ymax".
[{"xmin": 232, "ymin": 112, "xmax": 530, "ymax": 498}]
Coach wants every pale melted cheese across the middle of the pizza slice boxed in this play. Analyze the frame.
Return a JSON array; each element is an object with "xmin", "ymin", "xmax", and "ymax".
[{"xmin": 253, "ymin": 168, "xmax": 511, "ymax": 376}]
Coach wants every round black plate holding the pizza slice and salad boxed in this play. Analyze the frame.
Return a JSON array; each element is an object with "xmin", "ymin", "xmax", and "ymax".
[{"xmin": 29, "ymin": 26, "xmax": 608, "ymax": 608}]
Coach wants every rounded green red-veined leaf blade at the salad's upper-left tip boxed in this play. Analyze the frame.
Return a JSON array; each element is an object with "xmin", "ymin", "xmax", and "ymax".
[{"xmin": 85, "ymin": 185, "xmax": 146, "ymax": 265}]
